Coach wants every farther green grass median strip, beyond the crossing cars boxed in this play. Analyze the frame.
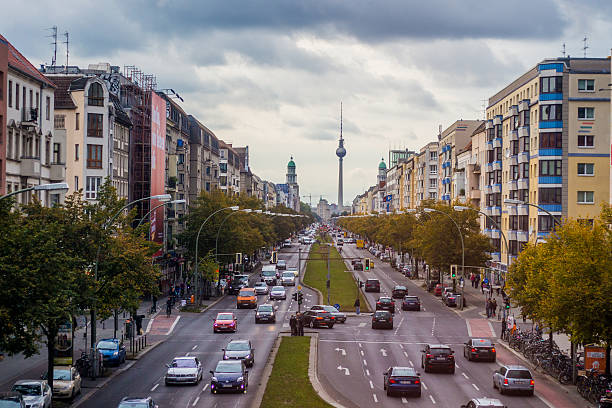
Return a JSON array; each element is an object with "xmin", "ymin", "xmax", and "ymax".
[{"xmin": 304, "ymin": 244, "xmax": 370, "ymax": 313}]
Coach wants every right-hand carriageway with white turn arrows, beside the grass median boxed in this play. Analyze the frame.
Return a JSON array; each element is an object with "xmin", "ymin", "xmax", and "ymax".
[{"xmin": 318, "ymin": 245, "xmax": 575, "ymax": 408}]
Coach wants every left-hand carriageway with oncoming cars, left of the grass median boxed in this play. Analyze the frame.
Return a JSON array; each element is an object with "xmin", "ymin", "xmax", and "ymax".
[{"xmin": 81, "ymin": 243, "xmax": 316, "ymax": 408}]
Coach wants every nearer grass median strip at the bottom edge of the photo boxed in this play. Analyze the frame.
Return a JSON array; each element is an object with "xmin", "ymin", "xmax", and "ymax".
[{"xmin": 260, "ymin": 336, "xmax": 331, "ymax": 408}]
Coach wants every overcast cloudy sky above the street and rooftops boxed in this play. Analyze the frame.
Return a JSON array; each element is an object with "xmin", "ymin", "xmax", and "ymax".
[{"xmin": 0, "ymin": 0, "xmax": 612, "ymax": 204}]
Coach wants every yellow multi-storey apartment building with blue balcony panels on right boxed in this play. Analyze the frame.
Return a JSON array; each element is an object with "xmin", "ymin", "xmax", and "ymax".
[{"xmin": 484, "ymin": 58, "xmax": 610, "ymax": 263}]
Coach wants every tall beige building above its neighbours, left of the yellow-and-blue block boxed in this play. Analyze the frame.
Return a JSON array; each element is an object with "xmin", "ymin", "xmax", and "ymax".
[{"xmin": 438, "ymin": 120, "xmax": 482, "ymax": 203}]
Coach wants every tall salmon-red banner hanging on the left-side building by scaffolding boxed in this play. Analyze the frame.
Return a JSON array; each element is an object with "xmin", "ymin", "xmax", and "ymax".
[{"xmin": 151, "ymin": 92, "xmax": 166, "ymax": 243}]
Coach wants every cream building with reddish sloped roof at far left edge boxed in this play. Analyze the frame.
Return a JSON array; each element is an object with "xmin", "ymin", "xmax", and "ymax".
[{"xmin": 0, "ymin": 36, "xmax": 66, "ymax": 205}]
